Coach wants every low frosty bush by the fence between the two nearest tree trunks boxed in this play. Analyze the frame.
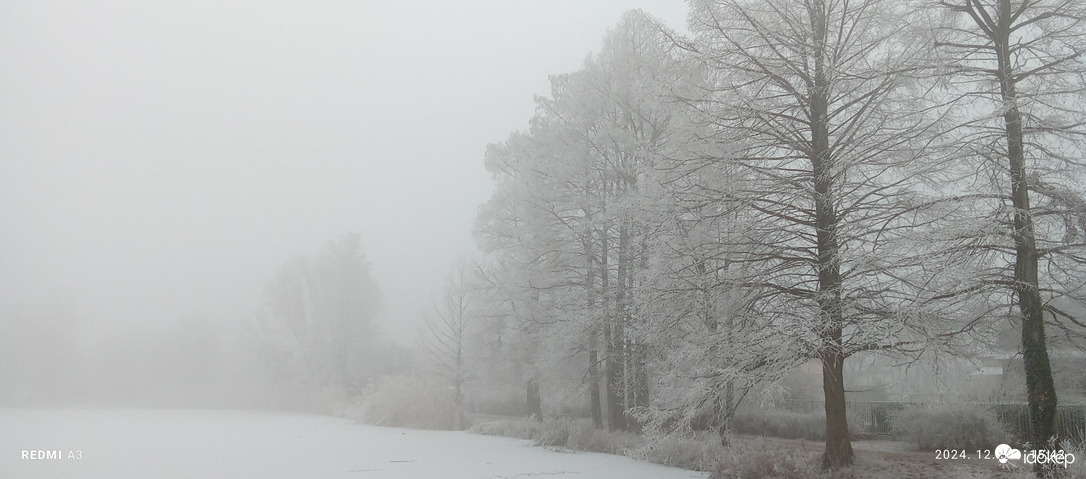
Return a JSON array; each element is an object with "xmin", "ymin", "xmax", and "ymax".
[{"xmin": 893, "ymin": 404, "xmax": 1009, "ymax": 451}]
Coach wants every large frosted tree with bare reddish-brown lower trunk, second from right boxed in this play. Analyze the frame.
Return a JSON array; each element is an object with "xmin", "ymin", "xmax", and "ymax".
[{"xmin": 687, "ymin": 0, "xmax": 955, "ymax": 469}]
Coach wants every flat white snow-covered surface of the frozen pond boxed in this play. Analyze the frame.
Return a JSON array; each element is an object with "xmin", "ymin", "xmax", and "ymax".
[{"xmin": 0, "ymin": 409, "xmax": 705, "ymax": 479}]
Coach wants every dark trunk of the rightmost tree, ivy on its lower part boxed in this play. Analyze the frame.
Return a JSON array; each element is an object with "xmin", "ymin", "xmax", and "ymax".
[{"xmin": 993, "ymin": 0, "xmax": 1057, "ymax": 458}]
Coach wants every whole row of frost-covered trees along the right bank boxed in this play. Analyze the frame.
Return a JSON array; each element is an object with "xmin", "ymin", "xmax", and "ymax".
[{"xmin": 453, "ymin": 0, "xmax": 1086, "ymax": 468}]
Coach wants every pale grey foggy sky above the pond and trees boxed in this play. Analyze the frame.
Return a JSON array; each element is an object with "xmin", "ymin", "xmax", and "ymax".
[{"xmin": 0, "ymin": 0, "xmax": 686, "ymax": 339}]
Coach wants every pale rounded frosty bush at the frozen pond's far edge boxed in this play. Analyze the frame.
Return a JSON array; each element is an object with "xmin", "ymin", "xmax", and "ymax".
[{"xmin": 350, "ymin": 376, "xmax": 466, "ymax": 429}]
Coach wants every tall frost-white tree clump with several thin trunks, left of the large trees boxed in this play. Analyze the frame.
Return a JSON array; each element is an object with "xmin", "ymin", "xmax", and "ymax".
[{"xmin": 479, "ymin": 12, "xmax": 682, "ymax": 429}]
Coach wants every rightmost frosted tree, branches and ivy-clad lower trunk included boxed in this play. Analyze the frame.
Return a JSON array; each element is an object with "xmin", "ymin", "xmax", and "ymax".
[{"xmin": 936, "ymin": 0, "xmax": 1086, "ymax": 462}]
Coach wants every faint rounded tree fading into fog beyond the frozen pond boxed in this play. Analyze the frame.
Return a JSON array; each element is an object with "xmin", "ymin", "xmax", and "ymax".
[{"xmin": 257, "ymin": 234, "xmax": 380, "ymax": 393}]
